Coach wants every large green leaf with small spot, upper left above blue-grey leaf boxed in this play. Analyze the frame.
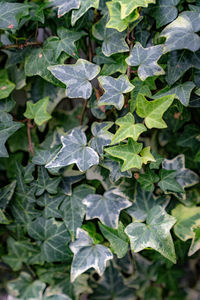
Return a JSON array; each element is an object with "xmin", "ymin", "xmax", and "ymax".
[{"xmin": 24, "ymin": 37, "xmax": 66, "ymax": 86}]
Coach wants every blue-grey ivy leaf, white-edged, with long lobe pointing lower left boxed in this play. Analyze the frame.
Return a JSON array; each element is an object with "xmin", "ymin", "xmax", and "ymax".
[{"xmin": 45, "ymin": 128, "xmax": 99, "ymax": 172}]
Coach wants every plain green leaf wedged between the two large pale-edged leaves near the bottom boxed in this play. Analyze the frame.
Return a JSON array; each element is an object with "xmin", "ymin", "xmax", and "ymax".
[{"xmin": 98, "ymin": 222, "xmax": 128, "ymax": 258}]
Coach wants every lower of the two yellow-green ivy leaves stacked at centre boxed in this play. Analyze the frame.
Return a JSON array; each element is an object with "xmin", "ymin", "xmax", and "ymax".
[{"xmin": 105, "ymin": 139, "xmax": 142, "ymax": 172}]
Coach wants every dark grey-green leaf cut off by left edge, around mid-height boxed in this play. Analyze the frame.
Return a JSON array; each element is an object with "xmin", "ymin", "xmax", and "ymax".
[{"xmin": 0, "ymin": 113, "xmax": 23, "ymax": 157}]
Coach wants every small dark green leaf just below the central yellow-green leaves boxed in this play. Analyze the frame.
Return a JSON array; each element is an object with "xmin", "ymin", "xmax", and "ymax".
[{"xmin": 137, "ymin": 168, "xmax": 159, "ymax": 192}]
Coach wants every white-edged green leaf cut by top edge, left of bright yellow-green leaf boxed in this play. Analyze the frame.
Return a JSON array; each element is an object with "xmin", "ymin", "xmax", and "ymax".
[{"xmin": 71, "ymin": 0, "xmax": 99, "ymax": 26}]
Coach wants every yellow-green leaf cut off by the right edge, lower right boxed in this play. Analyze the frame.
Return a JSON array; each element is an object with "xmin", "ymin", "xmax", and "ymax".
[{"xmin": 172, "ymin": 204, "xmax": 200, "ymax": 241}]
